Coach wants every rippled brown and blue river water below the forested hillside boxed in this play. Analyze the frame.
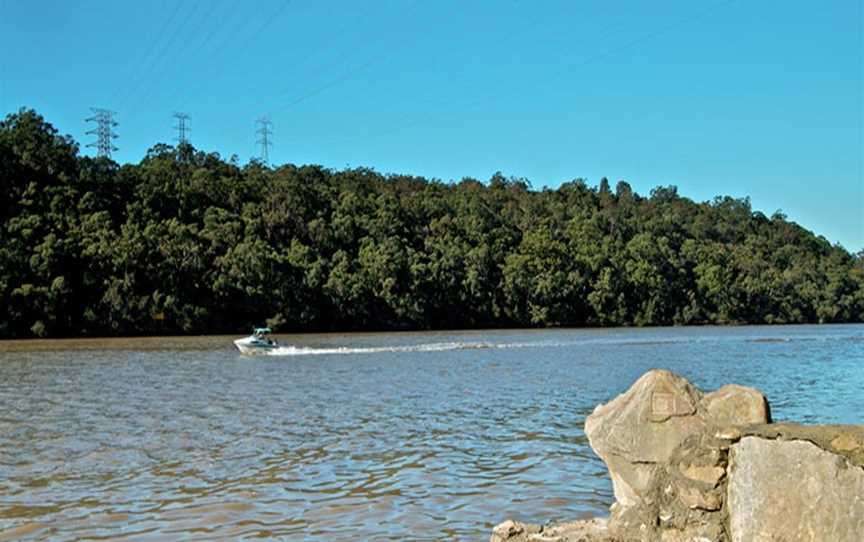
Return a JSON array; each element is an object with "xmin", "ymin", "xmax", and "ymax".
[{"xmin": 0, "ymin": 326, "xmax": 864, "ymax": 540}]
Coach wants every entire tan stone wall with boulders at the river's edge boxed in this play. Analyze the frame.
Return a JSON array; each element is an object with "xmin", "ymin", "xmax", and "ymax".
[{"xmin": 491, "ymin": 370, "xmax": 864, "ymax": 542}]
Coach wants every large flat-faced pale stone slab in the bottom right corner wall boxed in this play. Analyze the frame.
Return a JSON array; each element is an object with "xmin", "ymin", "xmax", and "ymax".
[{"xmin": 727, "ymin": 436, "xmax": 864, "ymax": 542}]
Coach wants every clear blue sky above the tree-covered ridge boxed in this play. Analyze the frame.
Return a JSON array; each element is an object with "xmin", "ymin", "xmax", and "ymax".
[{"xmin": 0, "ymin": 0, "xmax": 864, "ymax": 251}]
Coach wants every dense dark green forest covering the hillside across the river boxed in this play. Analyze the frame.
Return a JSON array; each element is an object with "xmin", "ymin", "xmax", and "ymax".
[{"xmin": 0, "ymin": 109, "xmax": 864, "ymax": 338}]
